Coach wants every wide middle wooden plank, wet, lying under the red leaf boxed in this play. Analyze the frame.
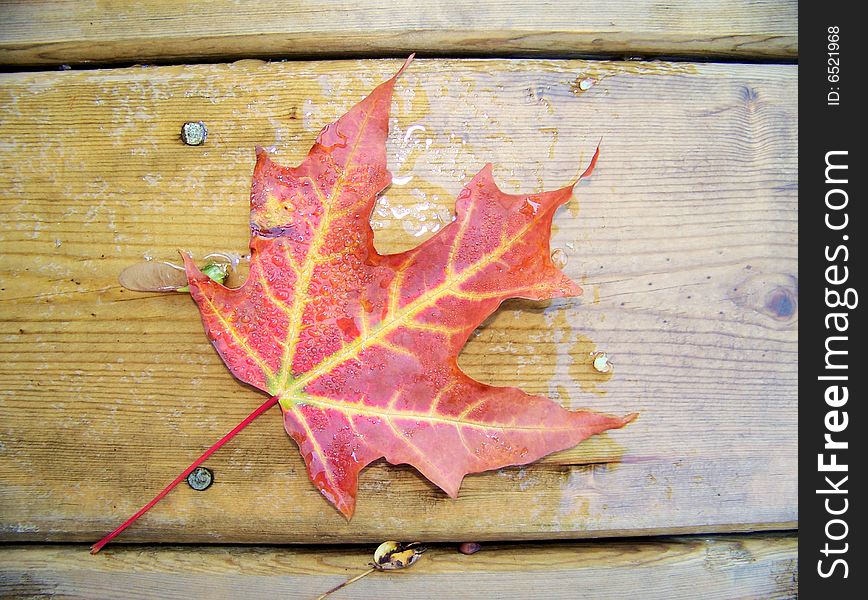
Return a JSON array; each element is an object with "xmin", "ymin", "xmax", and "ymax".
[{"xmin": 0, "ymin": 60, "xmax": 798, "ymax": 543}]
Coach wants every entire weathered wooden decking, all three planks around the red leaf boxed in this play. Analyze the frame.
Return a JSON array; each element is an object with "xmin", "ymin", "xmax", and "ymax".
[{"xmin": 0, "ymin": 2, "xmax": 798, "ymax": 597}]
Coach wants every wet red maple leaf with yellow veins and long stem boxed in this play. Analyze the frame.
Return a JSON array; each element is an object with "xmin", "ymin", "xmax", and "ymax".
[{"xmin": 94, "ymin": 57, "xmax": 635, "ymax": 551}]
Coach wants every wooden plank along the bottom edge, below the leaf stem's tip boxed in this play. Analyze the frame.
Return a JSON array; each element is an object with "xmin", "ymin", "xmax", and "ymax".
[{"xmin": 0, "ymin": 535, "xmax": 798, "ymax": 600}]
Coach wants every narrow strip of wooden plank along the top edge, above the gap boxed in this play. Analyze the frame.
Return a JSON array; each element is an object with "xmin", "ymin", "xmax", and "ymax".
[{"xmin": 0, "ymin": 0, "xmax": 798, "ymax": 65}]
